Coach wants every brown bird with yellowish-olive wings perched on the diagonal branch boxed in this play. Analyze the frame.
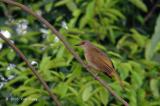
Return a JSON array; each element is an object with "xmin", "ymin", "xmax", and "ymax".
[{"xmin": 78, "ymin": 40, "xmax": 123, "ymax": 87}]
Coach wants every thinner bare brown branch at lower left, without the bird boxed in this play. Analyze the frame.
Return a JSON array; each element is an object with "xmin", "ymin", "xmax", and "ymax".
[{"xmin": 0, "ymin": 32, "xmax": 61, "ymax": 106}]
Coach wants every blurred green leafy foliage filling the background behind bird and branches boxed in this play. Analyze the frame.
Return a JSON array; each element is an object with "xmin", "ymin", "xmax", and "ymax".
[{"xmin": 0, "ymin": 0, "xmax": 160, "ymax": 106}]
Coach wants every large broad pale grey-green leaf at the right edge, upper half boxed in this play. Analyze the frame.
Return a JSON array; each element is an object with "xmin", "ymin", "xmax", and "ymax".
[{"xmin": 145, "ymin": 15, "xmax": 160, "ymax": 60}]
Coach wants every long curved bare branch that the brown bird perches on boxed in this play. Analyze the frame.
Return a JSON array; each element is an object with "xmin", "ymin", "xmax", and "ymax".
[{"xmin": 0, "ymin": 0, "xmax": 128, "ymax": 106}]
